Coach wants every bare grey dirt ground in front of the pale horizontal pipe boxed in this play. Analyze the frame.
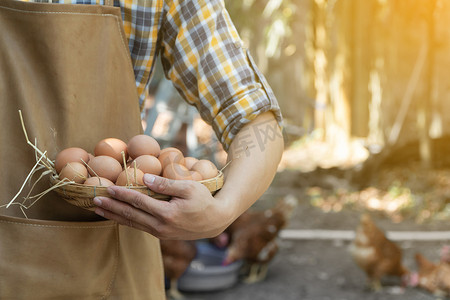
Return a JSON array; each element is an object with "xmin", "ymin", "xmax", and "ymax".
[{"xmin": 179, "ymin": 240, "xmax": 446, "ymax": 300}]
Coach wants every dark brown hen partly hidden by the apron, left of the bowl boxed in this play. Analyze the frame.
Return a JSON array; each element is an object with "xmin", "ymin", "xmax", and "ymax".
[{"xmin": 160, "ymin": 240, "xmax": 197, "ymax": 299}]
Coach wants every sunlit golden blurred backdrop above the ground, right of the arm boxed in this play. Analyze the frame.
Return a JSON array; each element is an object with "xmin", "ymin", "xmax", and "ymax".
[{"xmin": 226, "ymin": 0, "xmax": 450, "ymax": 152}]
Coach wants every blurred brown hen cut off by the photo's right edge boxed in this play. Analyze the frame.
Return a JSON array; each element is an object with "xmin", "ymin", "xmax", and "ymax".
[{"xmin": 415, "ymin": 253, "xmax": 450, "ymax": 296}]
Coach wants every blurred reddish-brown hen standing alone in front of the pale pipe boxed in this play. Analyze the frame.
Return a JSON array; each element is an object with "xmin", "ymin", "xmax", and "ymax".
[{"xmin": 350, "ymin": 214, "xmax": 409, "ymax": 290}]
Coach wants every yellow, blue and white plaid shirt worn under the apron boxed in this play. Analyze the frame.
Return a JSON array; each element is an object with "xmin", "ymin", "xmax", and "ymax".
[{"xmin": 23, "ymin": 0, "xmax": 282, "ymax": 148}]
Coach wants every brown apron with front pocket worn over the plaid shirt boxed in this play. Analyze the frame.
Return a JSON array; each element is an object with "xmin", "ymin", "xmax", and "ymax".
[{"xmin": 0, "ymin": 0, "xmax": 165, "ymax": 299}]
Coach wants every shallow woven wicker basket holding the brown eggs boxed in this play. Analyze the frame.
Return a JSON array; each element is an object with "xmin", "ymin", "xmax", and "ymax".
[{"xmin": 50, "ymin": 171, "xmax": 223, "ymax": 211}]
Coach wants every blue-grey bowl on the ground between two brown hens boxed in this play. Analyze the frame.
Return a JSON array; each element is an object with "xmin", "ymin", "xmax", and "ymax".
[{"xmin": 178, "ymin": 241, "xmax": 242, "ymax": 292}]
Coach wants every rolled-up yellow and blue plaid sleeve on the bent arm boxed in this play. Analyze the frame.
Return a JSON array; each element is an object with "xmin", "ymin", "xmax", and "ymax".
[{"xmin": 160, "ymin": 0, "xmax": 282, "ymax": 149}]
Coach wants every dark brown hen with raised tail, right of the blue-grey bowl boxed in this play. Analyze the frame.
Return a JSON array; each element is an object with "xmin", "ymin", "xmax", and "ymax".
[{"xmin": 224, "ymin": 196, "xmax": 297, "ymax": 283}]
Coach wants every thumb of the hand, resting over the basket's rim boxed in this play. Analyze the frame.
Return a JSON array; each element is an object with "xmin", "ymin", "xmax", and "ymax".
[{"xmin": 143, "ymin": 174, "xmax": 190, "ymax": 198}]
